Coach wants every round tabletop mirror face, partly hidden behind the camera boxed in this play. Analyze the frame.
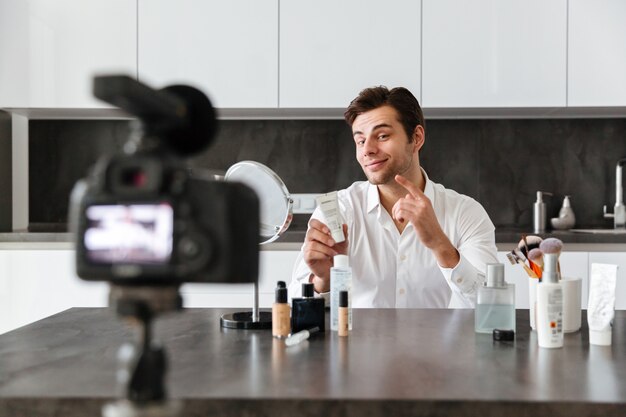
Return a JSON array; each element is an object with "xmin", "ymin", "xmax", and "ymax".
[{"xmin": 224, "ymin": 161, "xmax": 293, "ymax": 244}]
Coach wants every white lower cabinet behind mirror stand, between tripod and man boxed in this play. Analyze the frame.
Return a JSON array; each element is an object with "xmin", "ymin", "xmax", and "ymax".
[{"xmin": 181, "ymin": 250, "xmax": 300, "ymax": 311}]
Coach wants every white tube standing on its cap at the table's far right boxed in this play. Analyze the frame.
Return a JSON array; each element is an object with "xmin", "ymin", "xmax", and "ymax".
[{"xmin": 587, "ymin": 264, "xmax": 617, "ymax": 346}]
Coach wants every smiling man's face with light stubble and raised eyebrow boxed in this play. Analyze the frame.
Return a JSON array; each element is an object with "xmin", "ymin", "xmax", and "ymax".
[{"xmin": 352, "ymin": 106, "xmax": 423, "ymax": 185}]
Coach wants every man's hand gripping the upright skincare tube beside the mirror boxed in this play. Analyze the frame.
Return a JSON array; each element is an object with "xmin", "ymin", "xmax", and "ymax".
[{"xmin": 304, "ymin": 219, "xmax": 348, "ymax": 293}]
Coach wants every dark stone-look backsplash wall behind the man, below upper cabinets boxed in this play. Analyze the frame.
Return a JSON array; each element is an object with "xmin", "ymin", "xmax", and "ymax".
[{"xmin": 29, "ymin": 119, "xmax": 626, "ymax": 230}]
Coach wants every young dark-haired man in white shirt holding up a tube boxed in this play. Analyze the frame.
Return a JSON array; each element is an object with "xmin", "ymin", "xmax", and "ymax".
[{"xmin": 289, "ymin": 87, "xmax": 497, "ymax": 308}]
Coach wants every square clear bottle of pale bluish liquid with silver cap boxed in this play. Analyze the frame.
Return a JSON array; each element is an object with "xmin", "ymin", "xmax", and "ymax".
[{"xmin": 474, "ymin": 263, "xmax": 515, "ymax": 334}]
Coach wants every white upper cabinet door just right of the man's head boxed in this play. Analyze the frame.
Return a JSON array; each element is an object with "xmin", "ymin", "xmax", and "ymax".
[{"xmin": 422, "ymin": 0, "xmax": 567, "ymax": 107}]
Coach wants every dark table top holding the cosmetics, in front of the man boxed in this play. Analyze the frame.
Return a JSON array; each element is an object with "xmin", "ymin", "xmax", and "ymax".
[{"xmin": 0, "ymin": 308, "xmax": 626, "ymax": 417}]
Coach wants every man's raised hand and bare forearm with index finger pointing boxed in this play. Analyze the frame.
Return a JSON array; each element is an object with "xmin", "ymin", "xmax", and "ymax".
[{"xmin": 391, "ymin": 175, "xmax": 460, "ymax": 268}]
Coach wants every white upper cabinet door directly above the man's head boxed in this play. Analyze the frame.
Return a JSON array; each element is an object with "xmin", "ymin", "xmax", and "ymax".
[{"xmin": 280, "ymin": 0, "xmax": 420, "ymax": 108}]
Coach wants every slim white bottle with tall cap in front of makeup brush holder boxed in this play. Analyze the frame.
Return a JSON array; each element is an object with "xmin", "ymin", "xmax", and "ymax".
[{"xmin": 536, "ymin": 253, "xmax": 563, "ymax": 348}]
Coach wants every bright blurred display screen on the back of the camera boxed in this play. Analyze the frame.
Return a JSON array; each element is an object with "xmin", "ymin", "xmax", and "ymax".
[{"xmin": 84, "ymin": 203, "xmax": 174, "ymax": 265}]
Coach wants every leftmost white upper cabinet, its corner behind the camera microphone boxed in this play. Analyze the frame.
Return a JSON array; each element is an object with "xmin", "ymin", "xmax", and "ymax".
[{"xmin": 0, "ymin": 0, "xmax": 137, "ymax": 108}]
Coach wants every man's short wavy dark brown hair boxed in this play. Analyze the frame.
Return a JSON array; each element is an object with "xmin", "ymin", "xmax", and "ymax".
[{"xmin": 343, "ymin": 85, "xmax": 426, "ymax": 142}]
